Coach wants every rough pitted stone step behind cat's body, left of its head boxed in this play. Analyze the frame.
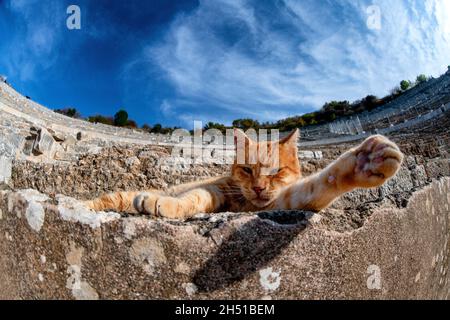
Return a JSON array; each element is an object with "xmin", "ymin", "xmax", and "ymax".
[{"xmin": 12, "ymin": 146, "xmax": 228, "ymax": 199}]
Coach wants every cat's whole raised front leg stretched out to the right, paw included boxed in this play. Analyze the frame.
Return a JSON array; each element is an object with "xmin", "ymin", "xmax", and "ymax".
[{"xmin": 272, "ymin": 135, "xmax": 403, "ymax": 211}]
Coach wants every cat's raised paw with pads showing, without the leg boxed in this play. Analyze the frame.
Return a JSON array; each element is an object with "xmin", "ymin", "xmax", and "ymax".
[{"xmin": 352, "ymin": 135, "xmax": 403, "ymax": 188}]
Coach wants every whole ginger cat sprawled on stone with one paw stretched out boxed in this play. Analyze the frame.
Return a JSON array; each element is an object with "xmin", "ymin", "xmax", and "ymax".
[{"xmin": 86, "ymin": 130, "xmax": 403, "ymax": 219}]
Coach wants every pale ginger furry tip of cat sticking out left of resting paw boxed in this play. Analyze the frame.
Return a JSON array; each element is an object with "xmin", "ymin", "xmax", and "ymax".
[{"xmin": 85, "ymin": 192, "xmax": 140, "ymax": 214}]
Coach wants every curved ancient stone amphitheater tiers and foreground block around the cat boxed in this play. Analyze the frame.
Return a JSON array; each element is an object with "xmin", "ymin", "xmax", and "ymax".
[{"xmin": 0, "ymin": 72, "xmax": 450, "ymax": 299}]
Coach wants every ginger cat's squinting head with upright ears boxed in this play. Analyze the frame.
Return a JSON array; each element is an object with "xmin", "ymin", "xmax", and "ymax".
[{"xmin": 232, "ymin": 130, "xmax": 301, "ymax": 208}]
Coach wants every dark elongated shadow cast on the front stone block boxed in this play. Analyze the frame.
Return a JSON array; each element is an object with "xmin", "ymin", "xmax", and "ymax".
[{"xmin": 192, "ymin": 212, "xmax": 307, "ymax": 292}]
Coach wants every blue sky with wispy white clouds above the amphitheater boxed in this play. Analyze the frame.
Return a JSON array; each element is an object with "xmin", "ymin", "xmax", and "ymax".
[{"xmin": 0, "ymin": 0, "xmax": 450, "ymax": 127}]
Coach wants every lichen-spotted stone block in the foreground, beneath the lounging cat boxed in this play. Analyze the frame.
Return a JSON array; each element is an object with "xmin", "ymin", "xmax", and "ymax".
[{"xmin": 0, "ymin": 178, "xmax": 450, "ymax": 299}]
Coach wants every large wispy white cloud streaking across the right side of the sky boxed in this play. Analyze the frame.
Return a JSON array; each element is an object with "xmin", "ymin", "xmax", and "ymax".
[{"xmin": 145, "ymin": 0, "xmax": 450, "ymax": 122}]
